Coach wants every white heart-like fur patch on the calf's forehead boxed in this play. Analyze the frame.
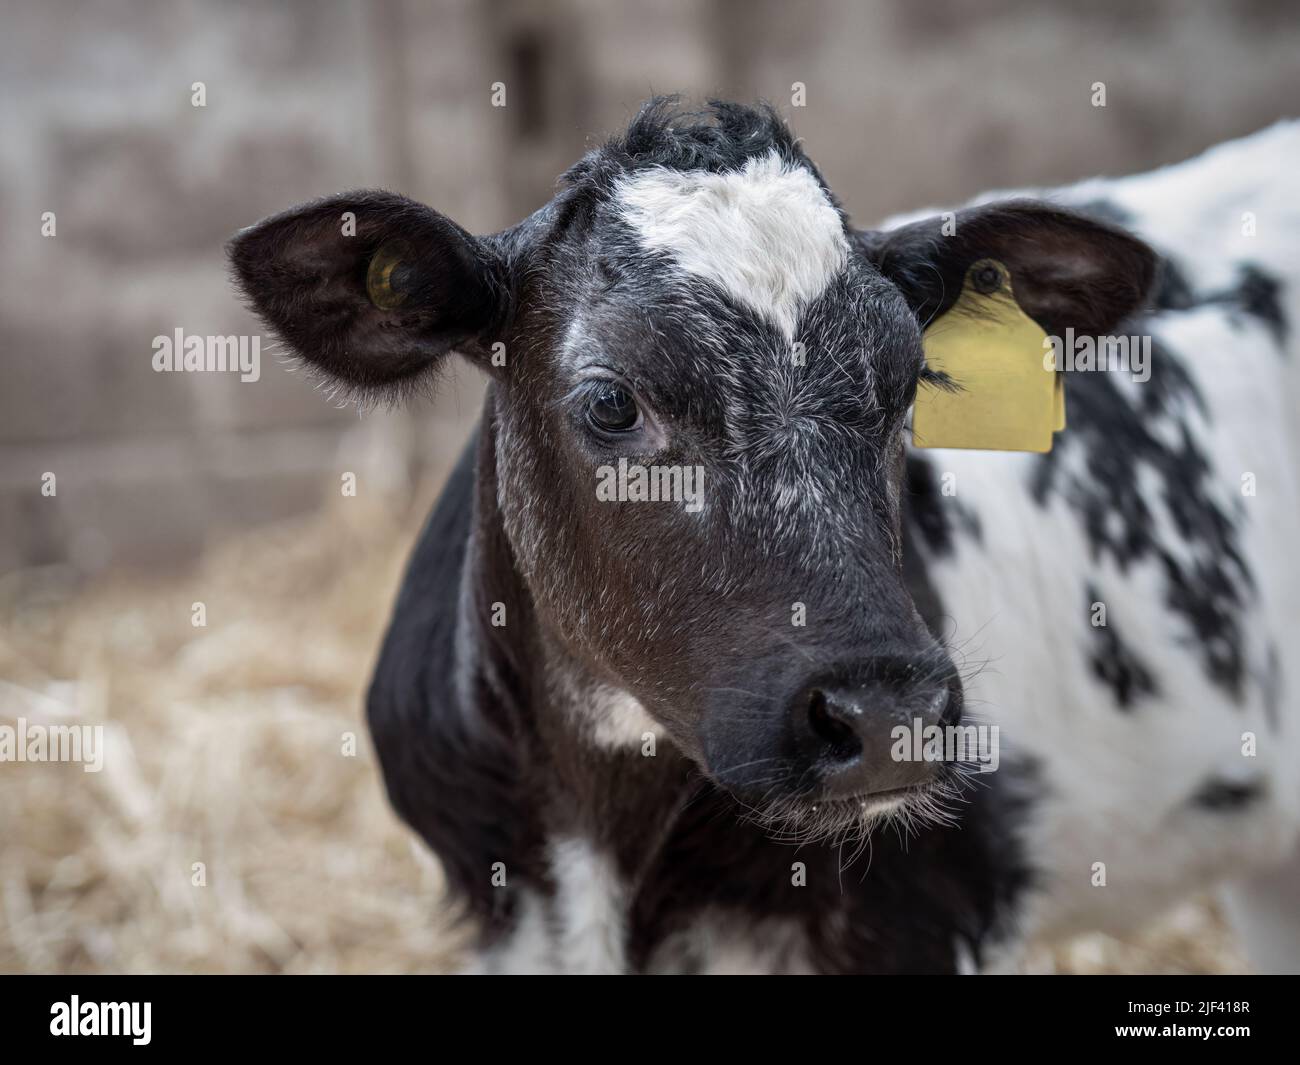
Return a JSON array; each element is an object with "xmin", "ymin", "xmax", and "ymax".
[{"xmin": 615, "ymin": 151, "xmax": 849, "ymax": 339}]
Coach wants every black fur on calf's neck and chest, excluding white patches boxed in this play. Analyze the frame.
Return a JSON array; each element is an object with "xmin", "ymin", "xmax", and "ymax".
[{"xmin": 369, "ymin": 418, "xmax": 1040, "ymax": 974}]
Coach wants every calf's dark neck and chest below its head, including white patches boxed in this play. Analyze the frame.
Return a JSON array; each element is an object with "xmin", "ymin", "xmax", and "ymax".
[{"xmin": 369, "ymin": 416, "xmax": 1026, "ymax": 973}]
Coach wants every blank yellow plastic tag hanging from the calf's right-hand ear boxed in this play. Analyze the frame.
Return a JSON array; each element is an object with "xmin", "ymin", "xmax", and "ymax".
[{"xmin": 911, "ymin": 259, "xmax": 1065, "ymax": 451}]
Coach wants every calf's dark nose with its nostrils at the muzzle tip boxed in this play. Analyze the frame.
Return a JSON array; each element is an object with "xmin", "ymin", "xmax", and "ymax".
[{"xmin": 790, "ymin": 658, "xmax": 961, "ymax": 798}]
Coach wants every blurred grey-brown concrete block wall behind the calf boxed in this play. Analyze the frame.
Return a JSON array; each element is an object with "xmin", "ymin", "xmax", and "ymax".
[{"xmin": 0, "ymin": 0, "xmax": 1300, "ymax": 572}]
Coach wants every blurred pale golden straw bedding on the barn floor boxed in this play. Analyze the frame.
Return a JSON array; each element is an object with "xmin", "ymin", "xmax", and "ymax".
[{"xmin": 0, "ymin": 492, "xmax": 1243, "ymax": 973}]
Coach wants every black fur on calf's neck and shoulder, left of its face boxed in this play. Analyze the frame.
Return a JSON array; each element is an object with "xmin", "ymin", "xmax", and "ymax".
[{"xmin": 367, "ymin": 429, "xmax": 545, "ymax": 935}]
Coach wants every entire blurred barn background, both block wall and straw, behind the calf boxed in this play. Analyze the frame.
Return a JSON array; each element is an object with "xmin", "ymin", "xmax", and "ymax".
[{"xmin": 0, "ymin": 0, "xmax": 1300, "ymax": 971}]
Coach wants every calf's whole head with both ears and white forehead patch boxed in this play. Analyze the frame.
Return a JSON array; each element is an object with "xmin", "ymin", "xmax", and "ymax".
[{"xmin": 231, "ymin": 101, "xmax": 1153, "ymax": 842}]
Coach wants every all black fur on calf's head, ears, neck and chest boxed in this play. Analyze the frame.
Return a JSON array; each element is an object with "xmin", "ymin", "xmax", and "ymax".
[{"xmin": 231, "ymin": 100, "xmax": 1152, "ymax": 973}]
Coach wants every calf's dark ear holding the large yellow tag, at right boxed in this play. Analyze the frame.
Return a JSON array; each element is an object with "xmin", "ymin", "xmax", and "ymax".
[{"xmin": 858, "ymin": 200, "xmax": 1156, "ymax": 335}]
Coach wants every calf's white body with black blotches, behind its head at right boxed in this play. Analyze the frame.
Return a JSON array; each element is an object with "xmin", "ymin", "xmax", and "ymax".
[{"xmin": 923, "ymin": 124, "xmax": 1300, "ymax": 951}]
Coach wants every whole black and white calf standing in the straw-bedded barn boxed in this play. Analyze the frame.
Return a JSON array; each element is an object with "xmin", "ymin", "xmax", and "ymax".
[{"xmin": 231, "ymin": 101, "xmax": 1300, "ymax": 973}]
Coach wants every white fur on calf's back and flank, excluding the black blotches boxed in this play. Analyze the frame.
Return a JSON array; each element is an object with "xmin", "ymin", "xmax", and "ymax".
[{"xmin": 909, "ymin": 124, "xmax": 1300, "ymax": 962}]
